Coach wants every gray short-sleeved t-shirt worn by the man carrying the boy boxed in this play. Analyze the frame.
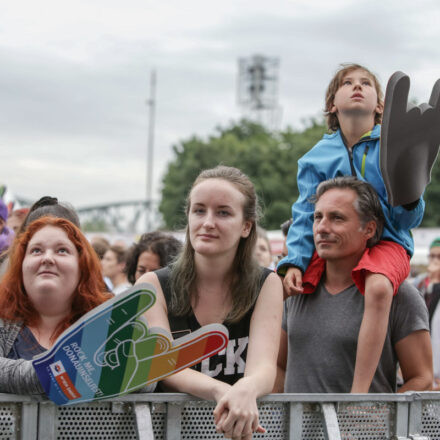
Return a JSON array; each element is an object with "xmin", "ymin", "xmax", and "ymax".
[{"xmin": 282, "ymin": 282, "xmax": 429, "ymax": 393}]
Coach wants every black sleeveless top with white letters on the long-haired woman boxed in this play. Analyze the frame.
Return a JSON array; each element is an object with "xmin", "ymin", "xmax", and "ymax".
[{"xmin": 154, "ymin": 267, "xmax": 273, "ymax": 385}]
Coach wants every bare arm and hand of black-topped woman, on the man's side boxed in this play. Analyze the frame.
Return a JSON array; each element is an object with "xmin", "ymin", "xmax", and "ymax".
[{"xmin": 214, "ymin": 273, "xmax": 283, "ymax": 437}]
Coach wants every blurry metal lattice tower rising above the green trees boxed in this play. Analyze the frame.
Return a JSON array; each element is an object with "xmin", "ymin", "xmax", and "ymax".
[{"xmin": 237, "ymin": 55, "xmax": 281, "ymax": 130}]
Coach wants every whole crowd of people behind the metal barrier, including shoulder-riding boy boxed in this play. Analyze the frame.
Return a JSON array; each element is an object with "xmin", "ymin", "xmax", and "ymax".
[{"xmin": 0, "ymin": 61, "xmax": 440, "ymax": 439}]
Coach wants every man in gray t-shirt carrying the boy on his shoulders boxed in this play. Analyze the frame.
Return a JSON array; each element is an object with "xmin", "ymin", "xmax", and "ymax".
[{"xmin": 275, "ymin": 177, "xmax": 432, "ymax": 393}]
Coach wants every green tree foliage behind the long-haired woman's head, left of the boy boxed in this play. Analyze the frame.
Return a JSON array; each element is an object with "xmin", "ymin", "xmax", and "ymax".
[{"xmin": 159, "ymin": 120, "xmax": 326, "ymax": 229}]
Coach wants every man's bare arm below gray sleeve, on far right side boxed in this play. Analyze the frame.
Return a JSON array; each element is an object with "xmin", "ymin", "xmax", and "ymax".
[{"xmin": 394, "ymin": 330, "xmax": 433, "ymax": 393}]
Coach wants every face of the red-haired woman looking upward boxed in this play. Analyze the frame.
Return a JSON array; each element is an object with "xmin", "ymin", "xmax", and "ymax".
[{"xmin": 22, "ymin": 226, "xmax": 80, "ymax": 316}]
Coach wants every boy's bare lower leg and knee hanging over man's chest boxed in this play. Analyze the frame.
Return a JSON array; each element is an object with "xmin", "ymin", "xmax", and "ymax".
[{"xmin": 351, "ymin": 273, "xmax": 394, "ymax": 393}]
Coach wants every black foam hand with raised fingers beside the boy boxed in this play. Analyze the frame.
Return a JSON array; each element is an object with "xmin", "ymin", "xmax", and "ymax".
[{"xmin": 380, "ymin": 72, "xmax": 440, "ymax": 206}]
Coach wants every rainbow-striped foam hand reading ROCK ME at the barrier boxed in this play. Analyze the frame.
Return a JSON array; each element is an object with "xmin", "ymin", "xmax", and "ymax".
[{"xmin": 32, "ymin": 284, "xmax": 228, "ymax": 405}]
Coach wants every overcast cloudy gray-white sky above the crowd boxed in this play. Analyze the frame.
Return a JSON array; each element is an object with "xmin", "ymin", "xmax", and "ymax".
[{"xmin": 0, "ymin": 0, "xmax": 440, "ymax": 207}]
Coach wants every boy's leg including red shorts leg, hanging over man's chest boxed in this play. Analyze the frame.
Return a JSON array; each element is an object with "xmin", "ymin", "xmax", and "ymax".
[{"xmin": 351, "ymin": 241, "xmax": 409, "ymax": 393}]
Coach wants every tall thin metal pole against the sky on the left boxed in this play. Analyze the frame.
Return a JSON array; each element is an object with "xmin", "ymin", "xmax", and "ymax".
[{"xmin": 145, "ymin": 69, "xmax": 156, "ymax": 232}]
